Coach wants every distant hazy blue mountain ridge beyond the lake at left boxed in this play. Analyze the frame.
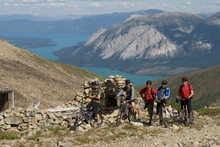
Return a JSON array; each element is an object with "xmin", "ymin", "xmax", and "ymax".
[{"xmin": 0, "ymin": 9, "xmax": 163, "ymax": 34}]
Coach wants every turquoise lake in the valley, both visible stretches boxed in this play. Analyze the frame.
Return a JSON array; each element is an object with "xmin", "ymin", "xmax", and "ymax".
[{"xmin": 0, "ymin": 33, "xmax": 165, "ymax": 86}]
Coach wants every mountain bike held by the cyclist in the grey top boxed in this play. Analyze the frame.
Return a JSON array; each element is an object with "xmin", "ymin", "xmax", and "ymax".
[{"xmin": 116, "ymin": 98, "xmax": 134, "ymax": 127}]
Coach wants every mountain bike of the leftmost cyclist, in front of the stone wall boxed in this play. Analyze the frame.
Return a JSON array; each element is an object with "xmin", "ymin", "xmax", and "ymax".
[{"xmin": 71, "ymin": 107, "xmax": 103, "ymax": 132}]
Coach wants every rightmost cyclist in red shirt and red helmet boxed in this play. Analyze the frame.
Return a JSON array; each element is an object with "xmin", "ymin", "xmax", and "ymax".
[{"xmin": 176, "ymin": 77, "xmax": 194, "ymax": 119}]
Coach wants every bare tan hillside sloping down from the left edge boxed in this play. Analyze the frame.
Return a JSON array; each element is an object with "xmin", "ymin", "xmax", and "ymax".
[{"xmin": 0, "ymin": 40, "xmax": 104, "ymax": 108}]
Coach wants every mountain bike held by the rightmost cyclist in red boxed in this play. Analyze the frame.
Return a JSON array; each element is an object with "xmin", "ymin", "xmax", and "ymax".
[{"xmin": 180, "ymin": 98, "xmax": 194, "ymax": 126}]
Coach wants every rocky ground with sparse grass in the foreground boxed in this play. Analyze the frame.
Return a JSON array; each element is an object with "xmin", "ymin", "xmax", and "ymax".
[{"xmin": 0, "ymin": 109, "xmax": 220, "ymax": 147}]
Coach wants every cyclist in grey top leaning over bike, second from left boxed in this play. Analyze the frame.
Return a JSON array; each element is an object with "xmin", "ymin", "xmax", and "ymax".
[{"xmin": 115, "ymin": 80, "xmax": 136, "ymax": 120}]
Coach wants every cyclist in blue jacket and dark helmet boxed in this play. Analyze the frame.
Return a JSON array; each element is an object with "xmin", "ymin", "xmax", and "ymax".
[{"xmin": 156, "ymin": 80, "xmax": 170, "ymax": 125}]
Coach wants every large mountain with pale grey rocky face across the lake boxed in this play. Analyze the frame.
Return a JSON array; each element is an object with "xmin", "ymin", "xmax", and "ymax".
[{"xmin": 54, "ymin": 12, "xmax": 220, "ymax": 76}]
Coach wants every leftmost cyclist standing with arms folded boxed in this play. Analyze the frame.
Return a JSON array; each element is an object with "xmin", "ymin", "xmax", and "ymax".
[{"xmin": 86, "ymin": 81, "xmax": 101, "ymax": 127}]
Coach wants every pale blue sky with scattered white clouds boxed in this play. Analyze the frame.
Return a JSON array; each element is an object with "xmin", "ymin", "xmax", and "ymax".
[{"xmin": 0, "ymin": 0, "xmax": 220, "ymax": 16}]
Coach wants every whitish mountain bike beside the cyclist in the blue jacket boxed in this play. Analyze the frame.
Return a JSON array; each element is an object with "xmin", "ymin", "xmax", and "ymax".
[{"xmin": 156, "ymin": 98, "xmax": 180, "ymax": 128}]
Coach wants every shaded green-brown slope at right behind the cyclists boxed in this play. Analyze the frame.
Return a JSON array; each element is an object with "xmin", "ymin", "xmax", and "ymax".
[{"xmin": 135, "ymin": 66, "xmax": 220, "ymax": 109}]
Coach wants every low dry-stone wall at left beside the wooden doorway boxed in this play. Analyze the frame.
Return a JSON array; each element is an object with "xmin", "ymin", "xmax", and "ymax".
[{"xmin": 0, "ymin": 108, "xmax": 73, "ymax": 131}]
